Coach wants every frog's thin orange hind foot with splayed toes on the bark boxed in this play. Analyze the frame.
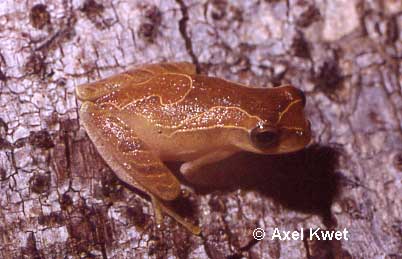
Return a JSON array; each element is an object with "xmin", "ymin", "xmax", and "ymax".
[{"xmin": 151, "ymin": 195, "xmax": 201, "ymax": 235}]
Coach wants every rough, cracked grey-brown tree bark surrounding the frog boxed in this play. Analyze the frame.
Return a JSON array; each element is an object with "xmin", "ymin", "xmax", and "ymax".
[{"xmin": 0, "ymin": 0, "xmax": 402, "ymax": 259}]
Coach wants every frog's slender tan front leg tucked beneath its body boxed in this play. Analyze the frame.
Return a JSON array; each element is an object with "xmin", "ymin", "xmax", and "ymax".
[{"xmin": 180, "ymin": 150, "xmax": 236, "ymax": 178}]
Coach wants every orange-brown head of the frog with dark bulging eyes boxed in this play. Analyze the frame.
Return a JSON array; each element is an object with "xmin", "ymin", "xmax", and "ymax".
[{"xmin": 236, "ymin": 86, "xmax": 311, "ymax": 154}]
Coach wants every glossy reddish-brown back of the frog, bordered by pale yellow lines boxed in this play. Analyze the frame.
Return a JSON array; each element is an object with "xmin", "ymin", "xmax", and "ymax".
[{"xmin": 114, "ymin": 73, "xmax": 264, "ymax": 127}]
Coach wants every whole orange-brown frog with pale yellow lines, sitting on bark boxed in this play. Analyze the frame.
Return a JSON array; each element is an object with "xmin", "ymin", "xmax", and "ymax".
[{"xmin": 76, "ymin": 62, "xmax": 311, "ymax": 235}]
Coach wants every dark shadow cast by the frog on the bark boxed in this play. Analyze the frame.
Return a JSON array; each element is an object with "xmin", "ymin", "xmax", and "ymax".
[{"xmin": 169, "ymin": 145, "xmax": 340, "ymax": 227}]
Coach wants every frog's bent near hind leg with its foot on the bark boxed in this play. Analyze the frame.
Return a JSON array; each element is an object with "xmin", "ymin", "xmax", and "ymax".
[{"xmin": 80, "ymin": 102, "xmax": 200, "ymax": 234}]
